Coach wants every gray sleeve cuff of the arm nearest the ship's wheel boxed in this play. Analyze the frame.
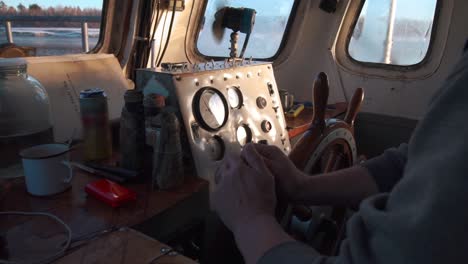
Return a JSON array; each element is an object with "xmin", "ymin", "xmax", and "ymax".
[{"xmin": 362, "ymin": 144, "xmax": 408, "ymax": 192}]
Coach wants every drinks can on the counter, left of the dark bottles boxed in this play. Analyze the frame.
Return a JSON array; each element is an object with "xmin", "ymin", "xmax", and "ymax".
[{"xmin": 80, "ymin": 88, "xmax": 112, "ymax": 160}]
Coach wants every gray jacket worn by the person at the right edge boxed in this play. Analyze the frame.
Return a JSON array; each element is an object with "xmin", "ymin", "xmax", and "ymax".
[{"xmin": 259, "ymin": 53, "xmax": 468, "ymax": 264}]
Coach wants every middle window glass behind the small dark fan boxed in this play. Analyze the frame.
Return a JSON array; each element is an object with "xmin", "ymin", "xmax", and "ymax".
[{"xmin": 197, "ymin": 0, "xmax": 295, "ymax": 59}]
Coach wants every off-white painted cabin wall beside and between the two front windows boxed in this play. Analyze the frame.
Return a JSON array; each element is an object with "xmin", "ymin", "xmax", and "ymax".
[{"xmin": 149, "ymin": 0, "xmax": 468, "ymax": 119}]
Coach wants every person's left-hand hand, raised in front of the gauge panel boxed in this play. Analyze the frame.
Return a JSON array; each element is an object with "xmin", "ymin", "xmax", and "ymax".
[{"xmin": 211, "ymin": 144, "xmax": 276, "ymax": 233}]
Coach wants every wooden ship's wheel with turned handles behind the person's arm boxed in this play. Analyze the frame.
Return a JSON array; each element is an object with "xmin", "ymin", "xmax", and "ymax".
[{"xmin": 277, "ymin": 73, "xmax": 364, "ymax": 255}]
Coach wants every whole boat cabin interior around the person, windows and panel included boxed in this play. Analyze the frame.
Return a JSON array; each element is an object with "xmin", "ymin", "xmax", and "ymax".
[{"xmin": 0, "ymin": 0, "xmax": 468, "ymax": 263}]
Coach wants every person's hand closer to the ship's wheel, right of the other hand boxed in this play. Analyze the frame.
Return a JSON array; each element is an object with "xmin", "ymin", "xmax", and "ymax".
[{"xmin": 254, "ymin": 144, "xmax": 307, "ymax": 202}]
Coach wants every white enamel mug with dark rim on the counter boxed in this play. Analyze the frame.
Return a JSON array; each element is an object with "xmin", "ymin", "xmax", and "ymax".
[{"xmin": 20, "ymin": 144, "xmax": 73, "ymax": 196}]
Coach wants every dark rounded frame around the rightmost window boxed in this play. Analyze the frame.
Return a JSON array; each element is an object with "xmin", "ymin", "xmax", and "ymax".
[{"xmin": 345, "ymin": 0, "xmax": 443, "ymax": 71}]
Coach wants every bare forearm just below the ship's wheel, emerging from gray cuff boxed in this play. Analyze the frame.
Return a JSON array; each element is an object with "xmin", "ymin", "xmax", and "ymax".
[{"xmin": 295, "ymin": 166, "xmax": 378, "ymax": 207}]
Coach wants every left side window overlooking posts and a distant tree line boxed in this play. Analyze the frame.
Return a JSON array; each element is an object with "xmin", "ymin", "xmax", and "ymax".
[{"xmin": 0, "ymin": 0, "xmax": 104, "ymax": 57}]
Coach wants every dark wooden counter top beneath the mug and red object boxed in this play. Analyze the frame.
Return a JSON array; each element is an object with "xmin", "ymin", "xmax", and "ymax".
[{"xmin": 0, "ymin": 170, "xmax": 208, "ymax": 263}]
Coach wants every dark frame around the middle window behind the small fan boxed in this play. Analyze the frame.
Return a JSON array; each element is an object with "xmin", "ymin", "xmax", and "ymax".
[{"xmin": 194, "ymin": 0, "xmax": 301, "ymax": 61}]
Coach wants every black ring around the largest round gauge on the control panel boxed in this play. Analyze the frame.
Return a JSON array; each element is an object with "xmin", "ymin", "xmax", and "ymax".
[{"xmin": 192, "ymin": 86, "xmax": 229, "ymax": 132}]
